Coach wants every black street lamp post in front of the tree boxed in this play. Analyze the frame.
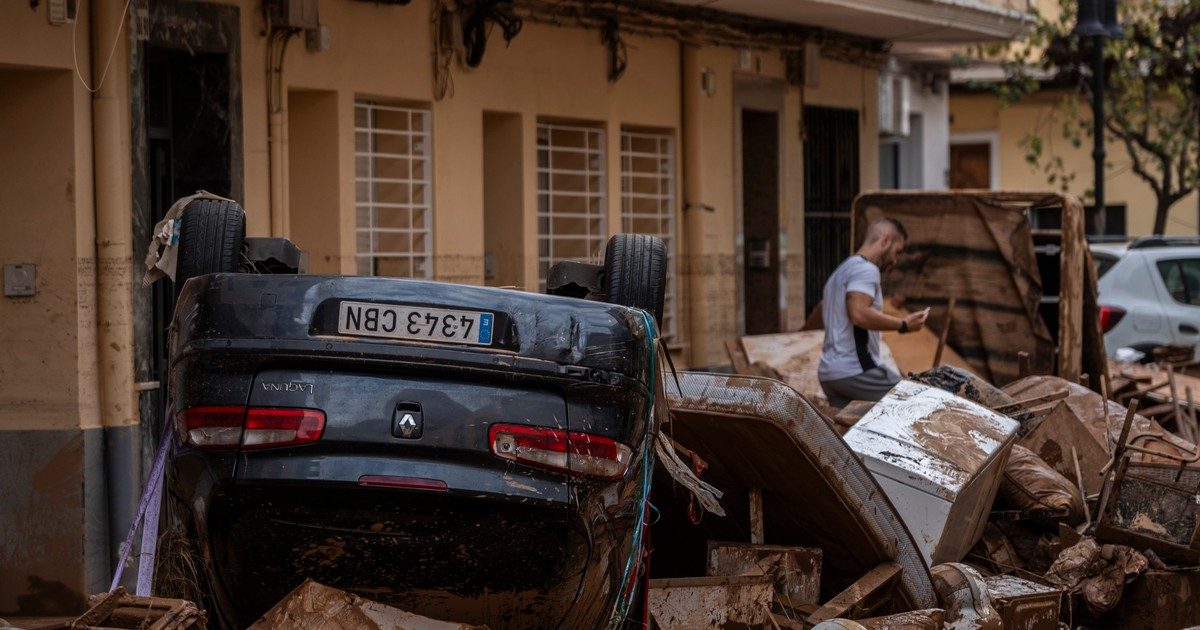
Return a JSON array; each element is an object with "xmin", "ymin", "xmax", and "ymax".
[{"xmin": 1073, "ymin": 0, "xmax": 1124, "ymax": 234}]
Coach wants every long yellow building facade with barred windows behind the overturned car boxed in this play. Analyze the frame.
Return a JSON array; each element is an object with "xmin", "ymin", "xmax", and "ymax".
[{"xmin": 0, "ymin": 0, "xmax": 1025, "ymax": 614}]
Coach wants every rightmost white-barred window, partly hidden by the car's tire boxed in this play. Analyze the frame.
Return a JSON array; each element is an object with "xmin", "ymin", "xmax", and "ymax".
[{"xmin": 620, "ymin": 130, "xmax": 678, "ymax": 342}]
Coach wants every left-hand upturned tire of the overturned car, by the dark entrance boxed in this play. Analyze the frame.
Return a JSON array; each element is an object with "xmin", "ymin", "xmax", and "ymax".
[{"xmin": 175, "ymin": 199, "xmax": 246, "ymax": 293}]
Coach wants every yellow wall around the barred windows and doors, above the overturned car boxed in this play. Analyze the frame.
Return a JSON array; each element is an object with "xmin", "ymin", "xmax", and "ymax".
[{"xmin": 211, "ymin": 0, "xmax": 878, "ymax": 365}]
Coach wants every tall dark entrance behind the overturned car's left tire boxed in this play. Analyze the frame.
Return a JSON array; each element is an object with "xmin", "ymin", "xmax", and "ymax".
[{"xmin": 131, "ymin": 2, "xmax": 242, "ymax": 448}]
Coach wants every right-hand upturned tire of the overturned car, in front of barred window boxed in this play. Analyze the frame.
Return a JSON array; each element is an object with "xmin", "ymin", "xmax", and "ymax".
[{"xmin": 604, "ymin": 234, "xmax": 667, "ymax": 326}]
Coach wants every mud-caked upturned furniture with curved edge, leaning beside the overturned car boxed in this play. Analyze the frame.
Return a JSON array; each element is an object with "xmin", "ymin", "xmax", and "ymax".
[{"xmin": 650, "ymin": 372, "xmax": 937, "ymax": 625}]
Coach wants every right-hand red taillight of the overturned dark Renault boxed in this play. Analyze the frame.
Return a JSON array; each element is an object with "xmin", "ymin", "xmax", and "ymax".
[{"xmin": 488, "ymin": 425, "xmax": 631, "ymax": 479}]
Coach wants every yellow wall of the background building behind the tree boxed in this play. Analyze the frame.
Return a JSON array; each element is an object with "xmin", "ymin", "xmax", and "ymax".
[{"xmin": 950, "ymin": 89, "xmax": 1200, "ymax": 236}]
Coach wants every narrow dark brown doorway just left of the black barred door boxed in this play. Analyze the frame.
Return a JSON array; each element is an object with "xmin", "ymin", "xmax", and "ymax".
[{"xmin": 742, "ymin": 109, "xmax": 780, "ymax": 335}]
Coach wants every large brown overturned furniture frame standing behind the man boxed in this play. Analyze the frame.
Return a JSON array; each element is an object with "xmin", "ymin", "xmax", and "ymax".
[{"xmin": 852, "ymin": 191, "xmax": 1106, "ymax": 385}]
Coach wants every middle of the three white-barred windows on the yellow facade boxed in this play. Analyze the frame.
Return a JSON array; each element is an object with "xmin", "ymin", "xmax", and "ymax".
[{"xmin": 538, "ymin": 121, "xmax": 608, "ymax": 292}]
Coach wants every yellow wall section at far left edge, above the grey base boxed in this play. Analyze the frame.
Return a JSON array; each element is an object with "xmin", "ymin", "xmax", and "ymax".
[{"xmin": 0, "ymin": 4, "xmax": 100, "ymax": 430}]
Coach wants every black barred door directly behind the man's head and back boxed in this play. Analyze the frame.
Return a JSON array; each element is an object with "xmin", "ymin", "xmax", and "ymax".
[{"xmin": 804, "ymin": 107, "xmax": 859, "ymax": 312}]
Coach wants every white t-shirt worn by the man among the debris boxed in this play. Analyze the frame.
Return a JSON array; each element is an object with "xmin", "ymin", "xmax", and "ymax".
[{"xmin": 817, "ymin": 254, "xmax": 883, "ymax": 380}]
